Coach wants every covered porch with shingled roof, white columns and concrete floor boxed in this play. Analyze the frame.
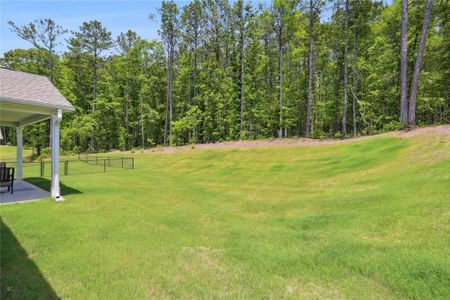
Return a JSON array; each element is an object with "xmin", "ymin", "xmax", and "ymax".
[{"xmin": 0, "ymin": 68, "xmax": 74, "ymax": 203}]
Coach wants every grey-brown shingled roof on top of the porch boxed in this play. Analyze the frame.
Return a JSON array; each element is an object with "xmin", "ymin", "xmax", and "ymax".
[{"xmin": 0, "ymin": 68, "xmax": 74, "ymax": 110}]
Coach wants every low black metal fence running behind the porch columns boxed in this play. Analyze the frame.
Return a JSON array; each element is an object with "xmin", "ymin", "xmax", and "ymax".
[{"xmin": 2, "ymin": 155, "xmax": 134, "ymax": 177}]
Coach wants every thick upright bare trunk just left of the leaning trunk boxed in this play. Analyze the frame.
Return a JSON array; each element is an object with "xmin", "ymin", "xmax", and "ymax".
[{"xmin": 400, "ymin": 0, "xmax": 408, "ymax": 125}]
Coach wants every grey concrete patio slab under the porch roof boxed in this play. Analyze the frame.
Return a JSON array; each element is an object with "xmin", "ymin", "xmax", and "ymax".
[{"xmin": 0, "ymin": 180, "xmax": 51, "ymax": 204}]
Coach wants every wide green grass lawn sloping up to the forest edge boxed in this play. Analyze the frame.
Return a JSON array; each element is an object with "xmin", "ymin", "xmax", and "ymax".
[{"xmin": 0, "ymin": 130, "xmax": 450, "ymax": 299}]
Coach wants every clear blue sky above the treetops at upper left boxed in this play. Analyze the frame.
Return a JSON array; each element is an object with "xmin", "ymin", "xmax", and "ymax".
[{"xmin": 0, "ymin": 0, "xmax": 188, "ymax": 55}]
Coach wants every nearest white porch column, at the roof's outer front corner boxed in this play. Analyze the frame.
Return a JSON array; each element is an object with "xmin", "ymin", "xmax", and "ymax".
[{"xmin": 50, "ymin": 109, "xmax": 64, "ymax": 201}]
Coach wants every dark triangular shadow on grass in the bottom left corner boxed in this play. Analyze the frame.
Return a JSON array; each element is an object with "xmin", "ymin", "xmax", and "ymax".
[{"xmin": 0, "ymin": 219, "xmax": 60, "ymax": 300}]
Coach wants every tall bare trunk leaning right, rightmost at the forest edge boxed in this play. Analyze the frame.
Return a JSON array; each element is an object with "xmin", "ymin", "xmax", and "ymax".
[{"xmin": 408, "ymin": 0, "xmax": 433, "ymax": 126}]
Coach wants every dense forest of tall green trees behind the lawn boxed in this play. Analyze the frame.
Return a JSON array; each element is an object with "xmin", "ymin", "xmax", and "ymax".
[{"xmin": 0, "ymin": 0, "xmax": 450, "ymax": 155}]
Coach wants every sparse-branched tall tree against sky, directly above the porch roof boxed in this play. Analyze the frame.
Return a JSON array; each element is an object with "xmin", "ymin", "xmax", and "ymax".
[{"xmin": 8, "ymin": 19, "xmax": 67, "ymax": 82}]
